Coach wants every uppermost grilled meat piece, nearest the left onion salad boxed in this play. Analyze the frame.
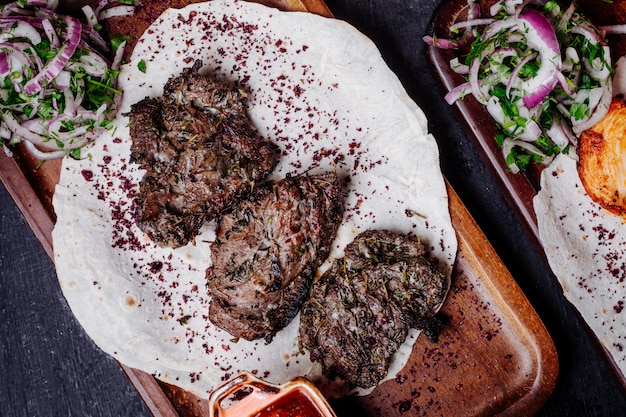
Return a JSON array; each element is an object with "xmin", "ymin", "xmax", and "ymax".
[{"xmin": 130, "ymin": 61, "xmax": 278, "ymax": 247}]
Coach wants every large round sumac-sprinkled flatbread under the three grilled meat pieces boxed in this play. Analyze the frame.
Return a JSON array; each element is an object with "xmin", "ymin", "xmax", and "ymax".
[{"xmin": 53, "ymin": 0, "xmax": 457, "ymax": 396}]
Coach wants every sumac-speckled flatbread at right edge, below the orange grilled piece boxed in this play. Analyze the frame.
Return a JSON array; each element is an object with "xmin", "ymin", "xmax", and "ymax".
[{"xmin": 534, "ymin": 155, "xmax": 626, "ymax": 375}]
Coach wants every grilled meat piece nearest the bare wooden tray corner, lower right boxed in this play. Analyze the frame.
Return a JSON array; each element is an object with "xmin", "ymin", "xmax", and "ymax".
[{"xmin": 300, "ymin": 230, "xmax": 448, "ymax": 388}]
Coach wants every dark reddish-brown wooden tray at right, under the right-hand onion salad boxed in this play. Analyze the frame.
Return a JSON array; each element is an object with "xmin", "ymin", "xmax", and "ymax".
[{"xmin": 426, "ymin": 0, "xmax": 626, "ymax": 390}]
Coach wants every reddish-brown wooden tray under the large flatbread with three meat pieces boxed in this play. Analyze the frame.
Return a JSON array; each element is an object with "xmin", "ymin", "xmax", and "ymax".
[{"xmin": 0, "ymin": 0, "xmax": 558, "ymax": 417}]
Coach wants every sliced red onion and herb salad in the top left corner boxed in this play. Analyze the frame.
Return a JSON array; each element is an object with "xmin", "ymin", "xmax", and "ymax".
[{"xmin": 0, "ymin": 0, "xmax": 133, "ymax": 161}]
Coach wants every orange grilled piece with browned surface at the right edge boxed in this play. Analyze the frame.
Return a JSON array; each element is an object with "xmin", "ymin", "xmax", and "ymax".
[{"xmin": 578, "ymin": 98, "xmax": 626, "ymax": 219}]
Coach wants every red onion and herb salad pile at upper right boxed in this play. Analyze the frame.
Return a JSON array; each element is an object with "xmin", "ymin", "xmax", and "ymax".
[{"xmin": 424, "ymin": 0, "xmax": 613, "ymax": 173}]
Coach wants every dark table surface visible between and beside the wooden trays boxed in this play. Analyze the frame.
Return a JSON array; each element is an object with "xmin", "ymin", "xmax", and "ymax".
[{"xmin": 0, "ymin": 0, "xmax": 626, "ymax": 417}]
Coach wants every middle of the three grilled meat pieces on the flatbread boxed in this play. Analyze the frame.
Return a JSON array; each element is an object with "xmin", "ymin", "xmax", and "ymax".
[{"xmin": 207, "ymin": 174, "xmax": 344, "ymax": 342}]
